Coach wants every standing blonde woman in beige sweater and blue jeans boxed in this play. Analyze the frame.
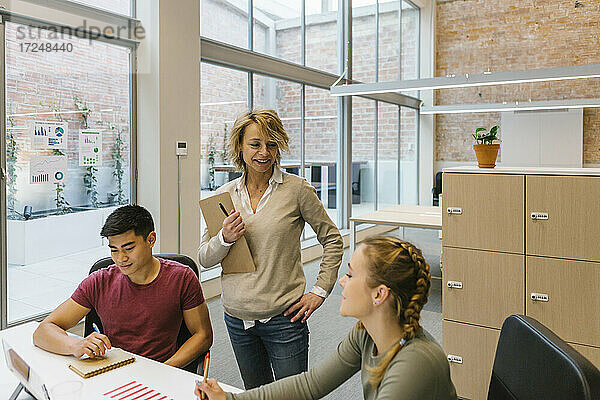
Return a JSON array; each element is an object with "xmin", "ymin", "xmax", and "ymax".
[{"xmin": 198, "ymin": 110, "xmax": 343, "ymax": 389}]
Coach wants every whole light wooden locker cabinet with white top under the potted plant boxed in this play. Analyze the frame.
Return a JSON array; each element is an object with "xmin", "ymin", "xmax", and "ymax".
[{"xmin": 442, "ymin": 167, "xmax": 600, "ymax": 400}]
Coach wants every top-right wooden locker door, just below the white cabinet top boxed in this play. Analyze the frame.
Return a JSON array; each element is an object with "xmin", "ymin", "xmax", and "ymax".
[{"xmin": 528, "ymin": 175, "xmax": 600, "ymax": 261}]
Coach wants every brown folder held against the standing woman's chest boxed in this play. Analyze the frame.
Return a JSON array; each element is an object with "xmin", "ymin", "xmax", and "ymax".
[{"xmin": 200, "ymin": 192, "xmax": 256, "ymax": 274}]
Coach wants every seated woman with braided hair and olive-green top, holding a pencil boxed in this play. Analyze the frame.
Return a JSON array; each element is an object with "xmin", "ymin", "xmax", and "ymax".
[{"xmin": 195, "ymin": 236, "xmax": 456, "ymax": 400}]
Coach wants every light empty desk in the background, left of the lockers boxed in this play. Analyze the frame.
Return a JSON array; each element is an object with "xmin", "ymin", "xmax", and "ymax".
[{"xmin": 350, "ymin": 204, "xmax": 442, "ymax": 252}]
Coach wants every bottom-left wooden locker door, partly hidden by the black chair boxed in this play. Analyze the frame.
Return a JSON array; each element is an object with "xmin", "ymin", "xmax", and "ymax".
[{"xmin": 442, "ymin": 320, "xmax": 500, "ymax": 400}]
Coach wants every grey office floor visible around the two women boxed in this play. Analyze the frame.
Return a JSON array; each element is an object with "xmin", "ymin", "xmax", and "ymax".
[{"xmin": 208, "ymin": 229, "xmax": 442, "ymax": 400}]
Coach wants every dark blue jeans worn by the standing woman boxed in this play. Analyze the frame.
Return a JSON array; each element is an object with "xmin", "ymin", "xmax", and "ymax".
[{"xmin": 225, "ymin": 313, "xmax": 308, "ymax": 390}]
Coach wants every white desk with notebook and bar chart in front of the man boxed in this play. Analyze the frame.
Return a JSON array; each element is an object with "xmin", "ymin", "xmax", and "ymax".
[{"xmin": 0, "ymin": 322, "xmax": 242, "ymax": 400}]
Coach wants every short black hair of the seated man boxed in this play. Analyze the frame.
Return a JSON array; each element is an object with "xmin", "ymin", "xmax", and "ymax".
[{"xmin": 100, "ymin": 205, "xmax": 154, "ymax": 239}]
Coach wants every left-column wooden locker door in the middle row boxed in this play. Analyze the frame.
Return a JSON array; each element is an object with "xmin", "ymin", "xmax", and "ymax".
[{"xmin": 442, "ymin": 250, "xmax": 525, "ymax": 329}]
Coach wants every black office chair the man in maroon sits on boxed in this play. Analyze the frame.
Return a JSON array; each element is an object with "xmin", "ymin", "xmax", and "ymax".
[{"xmin": 84, "ymin": 254, "xmax": 204, "ymax": 374}]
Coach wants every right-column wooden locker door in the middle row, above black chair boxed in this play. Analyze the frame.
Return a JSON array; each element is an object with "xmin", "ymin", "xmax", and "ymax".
[{"xmin": 525, "ymin": 256, "xmax": 600, "ymax": 346}]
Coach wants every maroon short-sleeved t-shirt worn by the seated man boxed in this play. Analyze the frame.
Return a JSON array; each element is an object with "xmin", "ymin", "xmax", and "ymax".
[{"xmin": 71, "ymin": 259, "xmax": 204, "ymax": 362}]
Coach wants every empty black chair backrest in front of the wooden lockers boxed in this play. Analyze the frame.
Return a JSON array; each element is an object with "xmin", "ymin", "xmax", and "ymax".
[{"xmin": 488, "ymin": 315, "xmax": 600, "ymax": 400}]
